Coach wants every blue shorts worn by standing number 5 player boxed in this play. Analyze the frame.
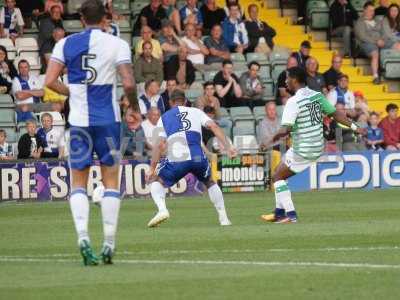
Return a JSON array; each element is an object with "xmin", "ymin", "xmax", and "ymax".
[{"xmin": 69, "ymin": 123, "xmax": 121, "ymax": 170}]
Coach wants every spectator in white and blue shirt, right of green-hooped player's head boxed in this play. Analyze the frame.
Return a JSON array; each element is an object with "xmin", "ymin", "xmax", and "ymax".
[{"xmin": 327, "ymin": 74, "xmax": 357, "ymax": 119}]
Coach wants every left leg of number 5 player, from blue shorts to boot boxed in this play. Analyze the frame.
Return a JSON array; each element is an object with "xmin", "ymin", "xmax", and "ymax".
[{"xmin": 69, "ymin": 127, "xmax": 98, "ymax": 265}]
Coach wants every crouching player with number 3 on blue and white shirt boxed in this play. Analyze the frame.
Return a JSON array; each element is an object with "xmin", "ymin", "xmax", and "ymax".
[{"xmin": 148, "ymin": 90, "xmax": 235, "ymax": 227}]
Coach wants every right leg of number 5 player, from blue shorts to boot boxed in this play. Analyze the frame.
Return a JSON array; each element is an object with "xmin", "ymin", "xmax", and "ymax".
[{"xmin": 94, "ymin": 123, "xmax": 121, "ymax": 264}]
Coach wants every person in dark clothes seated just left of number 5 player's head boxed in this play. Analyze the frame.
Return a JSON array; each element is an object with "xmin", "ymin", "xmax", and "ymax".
[{"xmin": 38, "ymin": 6, "xmax": 64, "ymax": 61}]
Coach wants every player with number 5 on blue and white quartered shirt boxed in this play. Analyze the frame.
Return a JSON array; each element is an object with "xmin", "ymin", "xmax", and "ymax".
[{"xmin": 45, "ymin": 0, "xmax": 138, "ymax": 265}]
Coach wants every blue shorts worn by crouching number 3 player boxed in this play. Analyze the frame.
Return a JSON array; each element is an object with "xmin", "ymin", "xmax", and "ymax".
[{"xmin": 158, "ymin": 158, "xmax": 211, "ymax": 187}]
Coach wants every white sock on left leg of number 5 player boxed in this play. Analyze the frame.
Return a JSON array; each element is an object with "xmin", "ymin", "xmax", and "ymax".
[{"xmin": 69, "ymin": 188, "xmax": 89, "ymax": 245}]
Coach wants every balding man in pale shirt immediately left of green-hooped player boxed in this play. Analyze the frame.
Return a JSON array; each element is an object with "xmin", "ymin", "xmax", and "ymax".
[{"xmin": 257, "ymin": 101, "xmax": 281, "ymax": 151}]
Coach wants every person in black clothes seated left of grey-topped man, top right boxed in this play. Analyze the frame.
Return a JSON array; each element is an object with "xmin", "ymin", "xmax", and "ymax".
[{"xmin": 329, "ymin": 0, "xmax": 358, "ymax": 57}]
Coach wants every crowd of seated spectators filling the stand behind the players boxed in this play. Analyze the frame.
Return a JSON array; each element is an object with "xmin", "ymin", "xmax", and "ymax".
[{"xmin": 0, "ymin": 0, "xmax": 400, "ymax": 159}]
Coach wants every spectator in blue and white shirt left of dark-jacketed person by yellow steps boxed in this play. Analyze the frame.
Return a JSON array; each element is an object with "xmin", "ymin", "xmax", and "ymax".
[{"xmin": 222, "ymin": 4, "xmax": 249, "ymax": 53}]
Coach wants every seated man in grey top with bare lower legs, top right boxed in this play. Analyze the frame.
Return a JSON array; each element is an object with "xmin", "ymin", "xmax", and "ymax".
[{"xmin": 354, "ymin": 1, "xmax": 400, "ymax": 84}]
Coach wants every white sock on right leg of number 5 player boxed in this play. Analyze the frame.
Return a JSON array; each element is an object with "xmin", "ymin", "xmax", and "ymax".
[{"xmin": 101, "ymin": 189, "xmax": 121, "ymax": 250}]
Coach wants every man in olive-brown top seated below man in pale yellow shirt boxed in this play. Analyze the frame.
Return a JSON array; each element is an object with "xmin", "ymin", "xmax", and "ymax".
[{"xmin": 134, "ymin": 41, "xmax": 164, "ymax": 90}]
